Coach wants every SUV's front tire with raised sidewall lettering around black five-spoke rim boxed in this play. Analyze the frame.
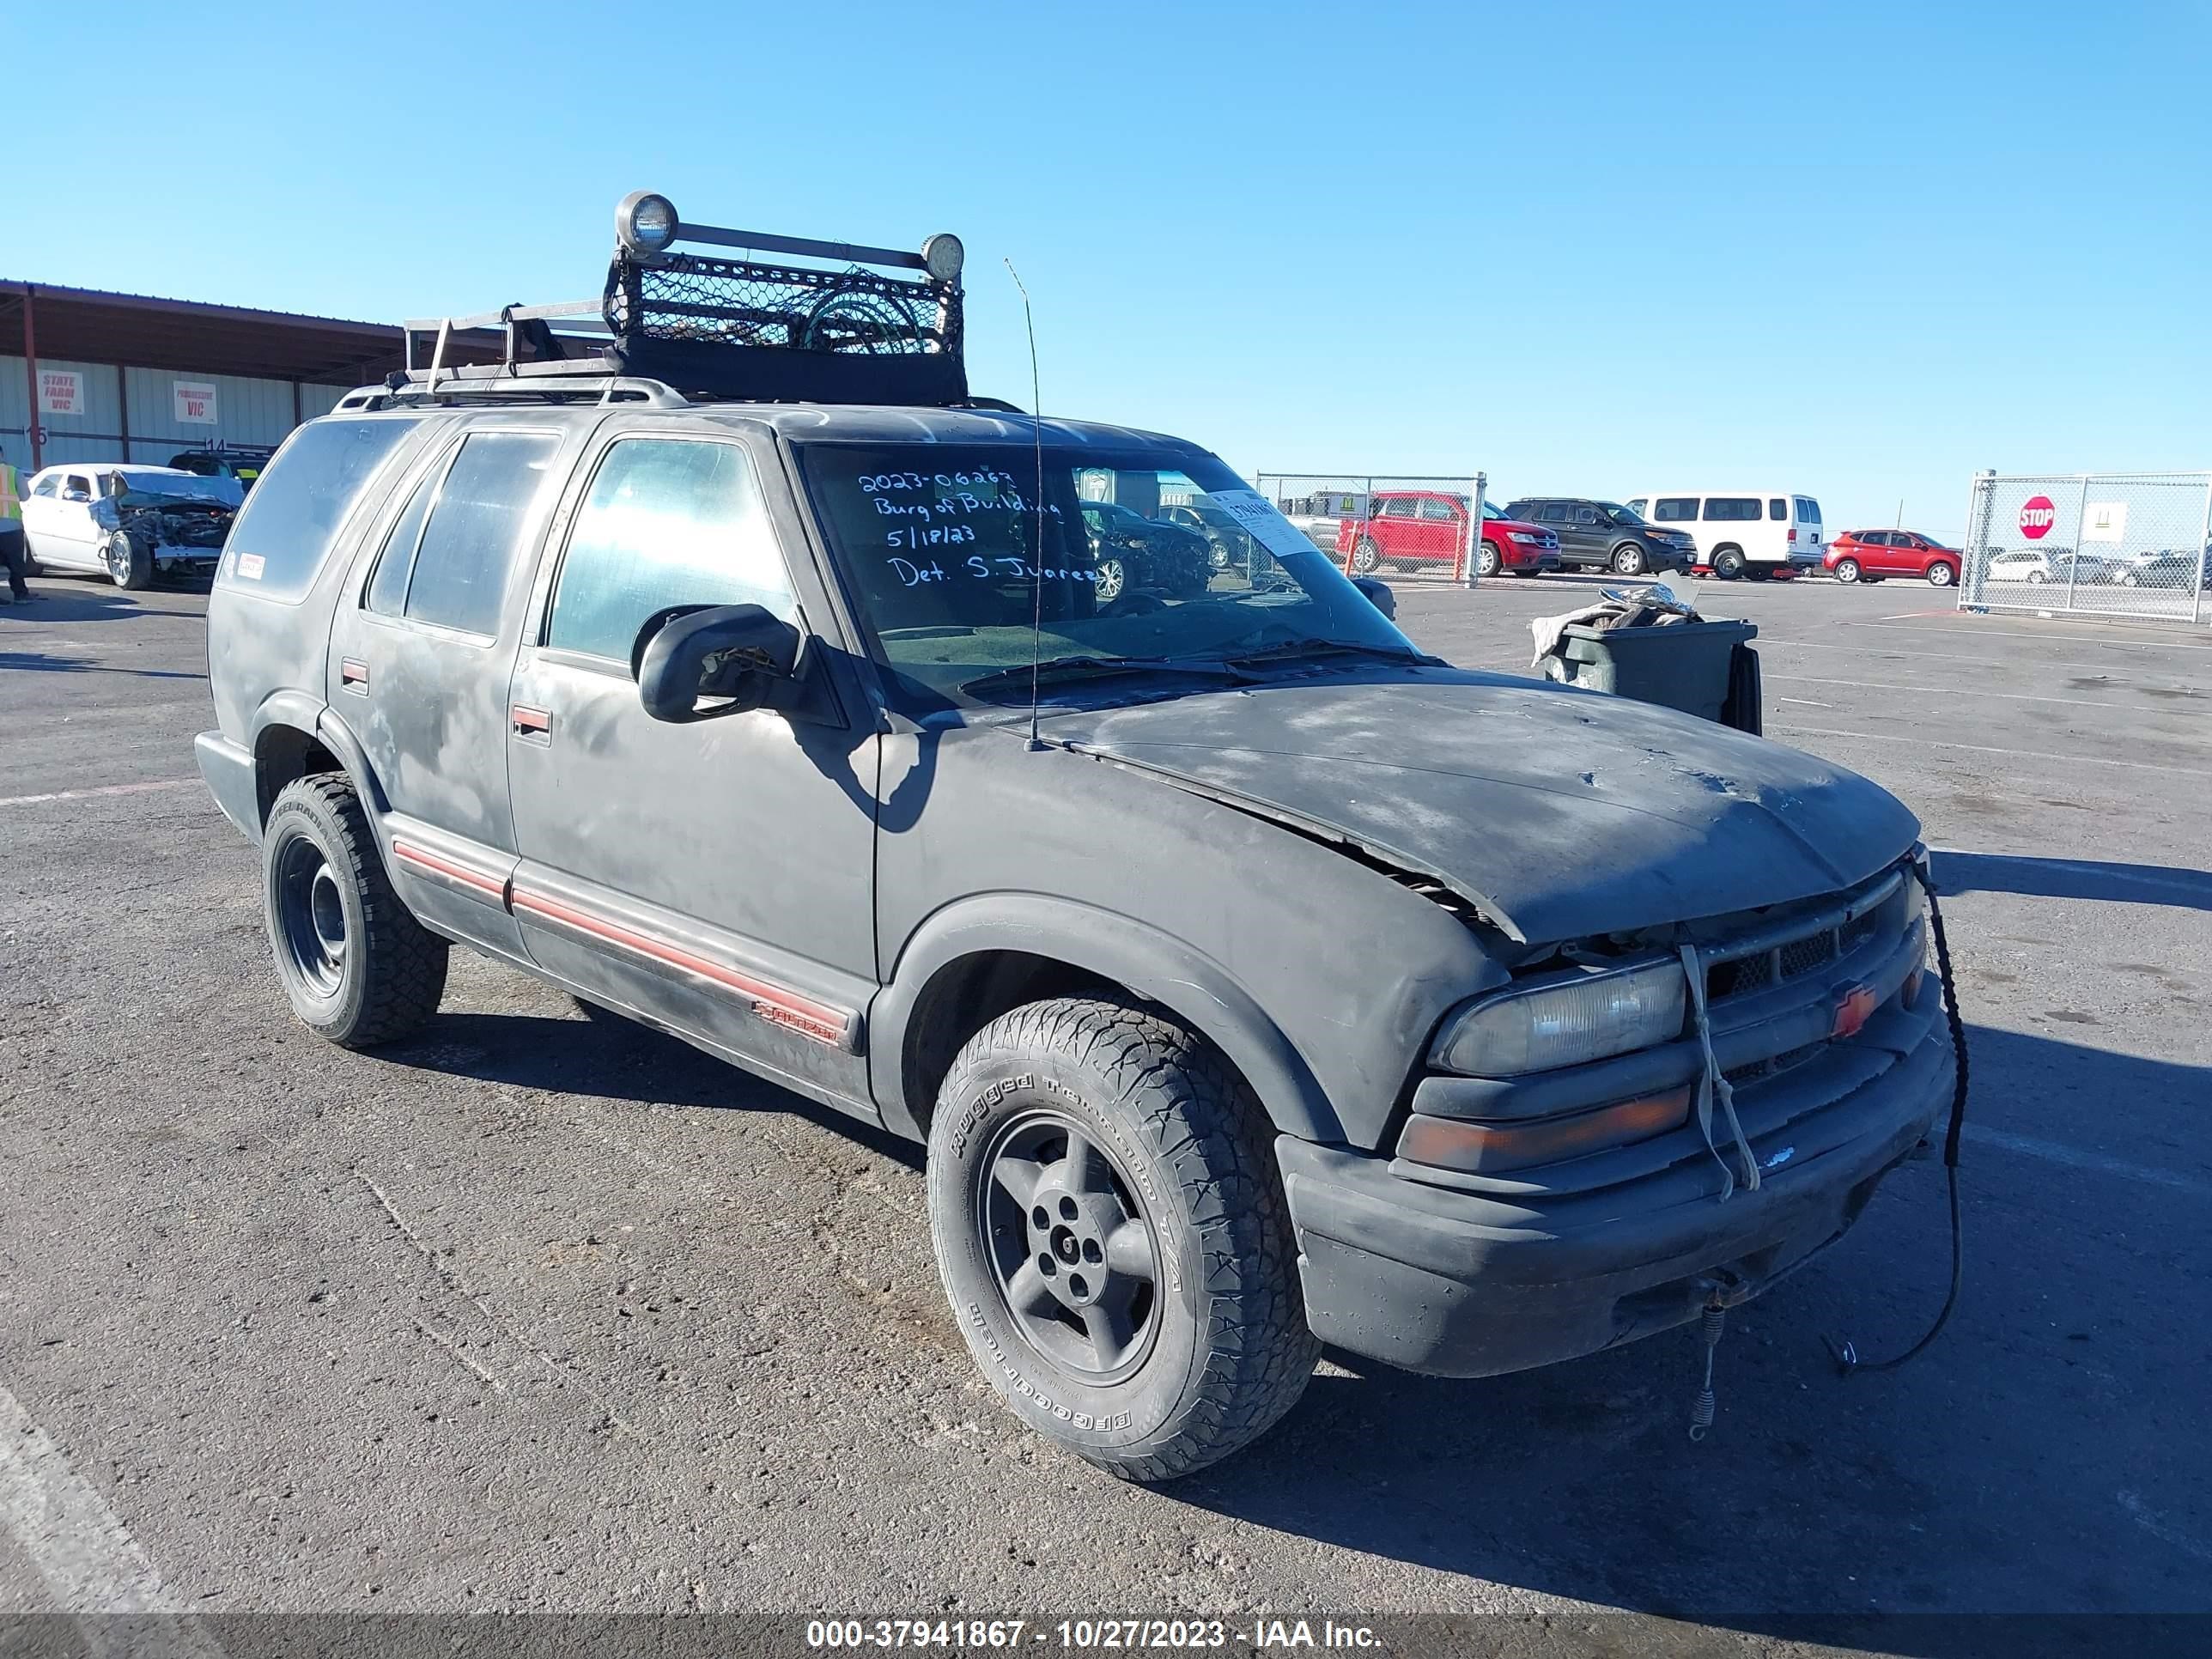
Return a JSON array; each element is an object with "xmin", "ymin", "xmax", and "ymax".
[{"xmin": 929, "ymin": 998, "xmax": 1321, "ymax": 1480}]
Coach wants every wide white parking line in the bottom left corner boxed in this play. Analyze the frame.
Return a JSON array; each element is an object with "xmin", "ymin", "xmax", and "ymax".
[{"xmin": 0, "ymin": 1389, "xmax": 223, "ymax": 1659}]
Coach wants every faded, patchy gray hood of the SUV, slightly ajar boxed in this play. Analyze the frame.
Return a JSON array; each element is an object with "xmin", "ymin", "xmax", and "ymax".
[{"xmin": 1044, "ymin": 668, "xmax": 1920, "ymax": 945}]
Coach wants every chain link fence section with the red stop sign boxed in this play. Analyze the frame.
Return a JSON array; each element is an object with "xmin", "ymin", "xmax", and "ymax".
[{"xmin": 1958, "ymin": 473, "xmax": 2212, "ymax": 622}]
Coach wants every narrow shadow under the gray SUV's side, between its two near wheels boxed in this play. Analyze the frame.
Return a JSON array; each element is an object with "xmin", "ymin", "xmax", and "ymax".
[{"xmin": 376, "ymin": 1013, "xmax": 922, "ymax": 1168}]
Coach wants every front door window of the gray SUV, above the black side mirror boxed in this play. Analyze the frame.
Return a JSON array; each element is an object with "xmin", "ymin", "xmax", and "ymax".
[{"xmin": 546, "ymin": 438, "xmax": 799, "ymax": 664}]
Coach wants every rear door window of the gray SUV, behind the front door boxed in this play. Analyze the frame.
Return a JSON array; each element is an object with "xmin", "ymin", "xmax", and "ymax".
[{"xmin": 369, "ymin": 431, "xmax": 560, "ymax": 637}]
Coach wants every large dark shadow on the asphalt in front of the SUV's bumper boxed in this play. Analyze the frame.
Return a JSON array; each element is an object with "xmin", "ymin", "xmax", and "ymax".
[{"xmin": 1164, "ymin": 1029, "xmax": 2212, "ymax": 1655}]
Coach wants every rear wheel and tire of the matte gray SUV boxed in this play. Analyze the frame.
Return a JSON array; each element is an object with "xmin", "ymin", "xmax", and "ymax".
[{"xmin": 261, "ymin": 772, "xmax": 447, "ymax": 1048}]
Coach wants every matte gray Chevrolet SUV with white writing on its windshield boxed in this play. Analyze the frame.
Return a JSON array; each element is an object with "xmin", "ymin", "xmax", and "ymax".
[{"xmin": 197, "ymin": 210, "xmax": 1954, "ymax": 1480}]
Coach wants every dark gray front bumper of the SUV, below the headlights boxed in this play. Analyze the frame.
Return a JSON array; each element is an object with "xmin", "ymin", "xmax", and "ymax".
[{"xmin": 1276, "ymin": 975, "xmax": 1954, "ymax": 1376}]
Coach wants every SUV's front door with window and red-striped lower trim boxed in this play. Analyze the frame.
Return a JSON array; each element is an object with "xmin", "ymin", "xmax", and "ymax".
[{"xmin": 507, "ymin": 420, "xmax": 876, "ymax": 1121}]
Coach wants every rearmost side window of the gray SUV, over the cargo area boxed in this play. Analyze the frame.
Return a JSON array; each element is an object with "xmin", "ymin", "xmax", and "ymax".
[{"xmin": 222, "ymin": 418, "xmax": 420, "ymax": 599}]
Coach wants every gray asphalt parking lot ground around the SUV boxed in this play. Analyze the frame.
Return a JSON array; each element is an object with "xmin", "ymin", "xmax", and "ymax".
[{"xmin": 0, "ymin": 577, "xmax": 2212, "ymax": 1646}]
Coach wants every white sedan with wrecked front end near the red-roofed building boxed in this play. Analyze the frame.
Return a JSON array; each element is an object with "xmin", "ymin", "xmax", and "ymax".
[{"xmin": 22, "ymin": 460, "xmax": 246, "ymax": 588}]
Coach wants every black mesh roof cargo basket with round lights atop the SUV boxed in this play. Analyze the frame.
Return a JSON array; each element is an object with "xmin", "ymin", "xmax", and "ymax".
[{"xmin": 387, "ymin": 191, "xmax": 969, "ymax": 407}]
